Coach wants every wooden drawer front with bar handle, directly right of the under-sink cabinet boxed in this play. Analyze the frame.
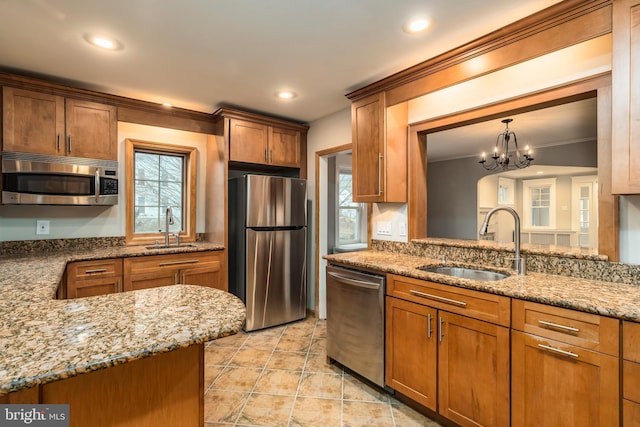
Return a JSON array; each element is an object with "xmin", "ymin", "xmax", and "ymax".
[{"xmin": 512, "ymin": 299, "xmax": 620, "ymax": 356}]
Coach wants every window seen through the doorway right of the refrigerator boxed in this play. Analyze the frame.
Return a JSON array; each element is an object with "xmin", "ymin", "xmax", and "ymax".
[{"xmin": 336, "ymin": 169, "xmax": 367, "ymax": 246}]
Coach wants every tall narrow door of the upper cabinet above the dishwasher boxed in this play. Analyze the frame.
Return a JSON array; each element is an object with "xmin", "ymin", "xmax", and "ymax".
[{"xmin": 351, "ymin": 93, "xmax": 385, "ymax": 202}]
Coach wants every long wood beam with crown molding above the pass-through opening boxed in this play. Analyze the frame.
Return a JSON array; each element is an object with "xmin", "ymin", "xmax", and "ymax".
[{"xmin": 346, "ymin": 0, "xmax": 612, "ymax": 106}]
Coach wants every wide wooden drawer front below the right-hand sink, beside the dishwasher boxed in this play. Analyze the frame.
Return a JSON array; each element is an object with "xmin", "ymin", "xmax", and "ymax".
[{"xmin": 387, "ymin": 274, "xmax": 511, "ymax": 326}]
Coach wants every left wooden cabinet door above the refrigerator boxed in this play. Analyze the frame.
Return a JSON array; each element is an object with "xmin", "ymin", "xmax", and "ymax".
[{"xmin": 229, "ymin": 119, "xmax": 269, "ymax": 164}]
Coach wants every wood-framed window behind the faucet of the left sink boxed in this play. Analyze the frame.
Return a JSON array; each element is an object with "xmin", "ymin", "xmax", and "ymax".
[{"xmin": 126, "ymin": 139, "xmax": 196, "ymax": 244}]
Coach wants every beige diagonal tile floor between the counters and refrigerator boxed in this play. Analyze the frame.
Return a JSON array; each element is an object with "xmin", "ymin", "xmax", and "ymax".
[{"xmin": 204, "ymin": 318, "xmax": 439, "ymax": 427}]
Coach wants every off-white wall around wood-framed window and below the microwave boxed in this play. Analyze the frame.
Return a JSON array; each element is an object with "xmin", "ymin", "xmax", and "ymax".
[{"xmin": 0, "ymin": 122, "xmax": 207, "ymax": 241}]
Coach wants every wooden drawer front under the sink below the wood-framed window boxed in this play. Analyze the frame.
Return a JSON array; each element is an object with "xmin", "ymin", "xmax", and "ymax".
[{"xmin": 124, "ymin": 252, "xmax": 219, "ymax": 275}]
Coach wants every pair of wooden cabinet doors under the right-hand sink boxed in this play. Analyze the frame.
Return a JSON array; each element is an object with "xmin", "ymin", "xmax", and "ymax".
[{"xmin": 386, "ymin": 297, "xmax": 510, "ymax": 427}]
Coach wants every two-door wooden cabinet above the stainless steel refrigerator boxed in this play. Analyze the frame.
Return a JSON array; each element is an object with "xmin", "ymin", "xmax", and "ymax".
[{"xmin": 229, "ymin": 119, "xmax": 302, "ymax": 168}]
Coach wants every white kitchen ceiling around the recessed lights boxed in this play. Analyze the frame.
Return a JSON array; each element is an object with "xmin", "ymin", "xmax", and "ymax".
[{"xmin": 0, "ymin": 0, "xmax": 558, "ymax": 122}]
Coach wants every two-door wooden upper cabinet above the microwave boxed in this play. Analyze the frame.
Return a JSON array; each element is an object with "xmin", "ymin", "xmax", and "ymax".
[{"xmin": 2, "ymin": 87, "xmax": 118, "ymax": 160}]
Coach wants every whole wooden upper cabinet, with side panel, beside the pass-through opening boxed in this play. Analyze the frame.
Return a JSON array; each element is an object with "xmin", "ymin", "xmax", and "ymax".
[{"xmin": 351, "ymin": 93, "xmax": 407, "ymax": 202}]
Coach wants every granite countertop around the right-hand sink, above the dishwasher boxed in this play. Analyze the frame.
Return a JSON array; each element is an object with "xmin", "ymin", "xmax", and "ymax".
[{"xmin": 325, "ymin": 250, "xmax": 640, "ymax": 321}]
